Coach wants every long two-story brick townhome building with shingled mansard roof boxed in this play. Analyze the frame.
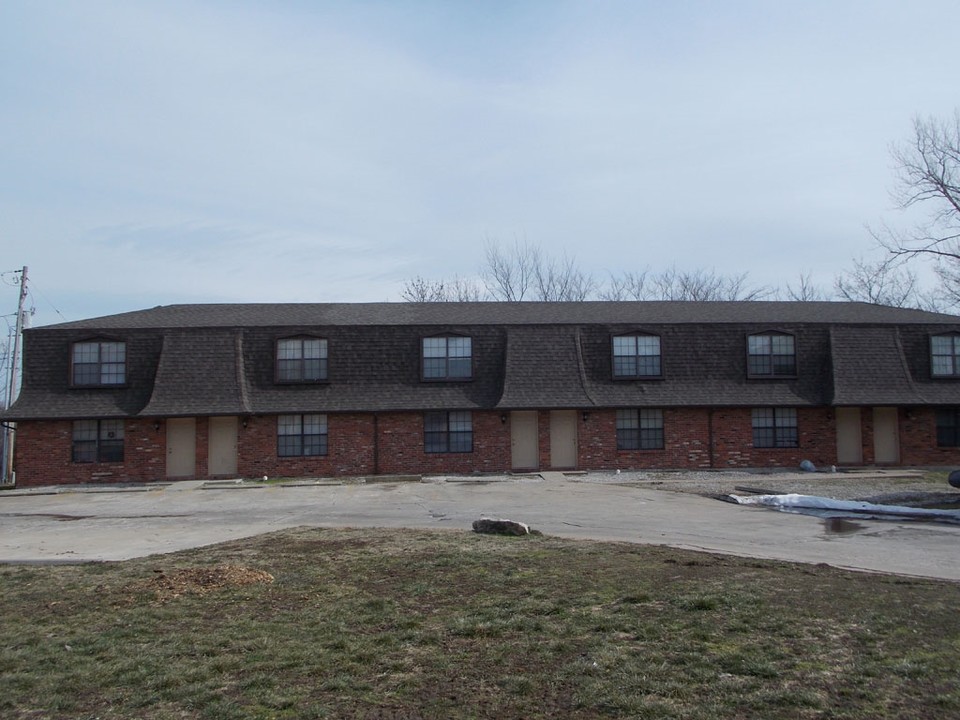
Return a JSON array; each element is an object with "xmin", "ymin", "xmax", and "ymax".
[{"xmin": 3, "ymin": 302, "xmax": 960, "ymax": 486}]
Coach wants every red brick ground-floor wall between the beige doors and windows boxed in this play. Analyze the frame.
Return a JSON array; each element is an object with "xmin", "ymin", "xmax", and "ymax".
[{"xmin": 9, "ymin": 408, "xmax": 960, "ymax": 486}]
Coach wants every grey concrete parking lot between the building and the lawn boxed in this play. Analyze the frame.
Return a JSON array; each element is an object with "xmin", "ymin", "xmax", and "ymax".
[{"xmin": 0, "ymin": 474, "xmax": 960, "ymax": 580}]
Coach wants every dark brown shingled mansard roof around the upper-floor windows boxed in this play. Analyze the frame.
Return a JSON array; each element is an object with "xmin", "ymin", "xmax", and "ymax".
[{"xmin": 4, "ymin": 302, "xmax": 960, "ymax": 420}]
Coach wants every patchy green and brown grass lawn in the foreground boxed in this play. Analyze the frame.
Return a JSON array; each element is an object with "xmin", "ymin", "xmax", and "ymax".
[{"xmin": 0, "ymin": 528, "xmax": 960, "ymax": 720}]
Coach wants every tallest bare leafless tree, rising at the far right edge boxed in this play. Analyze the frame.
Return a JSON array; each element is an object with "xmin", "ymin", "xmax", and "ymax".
[{"xmin": 871, "ymin": 109, "xmax": 960, "ymax": 304}]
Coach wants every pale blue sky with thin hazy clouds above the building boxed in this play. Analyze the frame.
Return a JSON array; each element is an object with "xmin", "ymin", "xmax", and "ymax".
[{"xmin": 0, "ymin": 0, "xmax": 960, "ymax": 325}]
